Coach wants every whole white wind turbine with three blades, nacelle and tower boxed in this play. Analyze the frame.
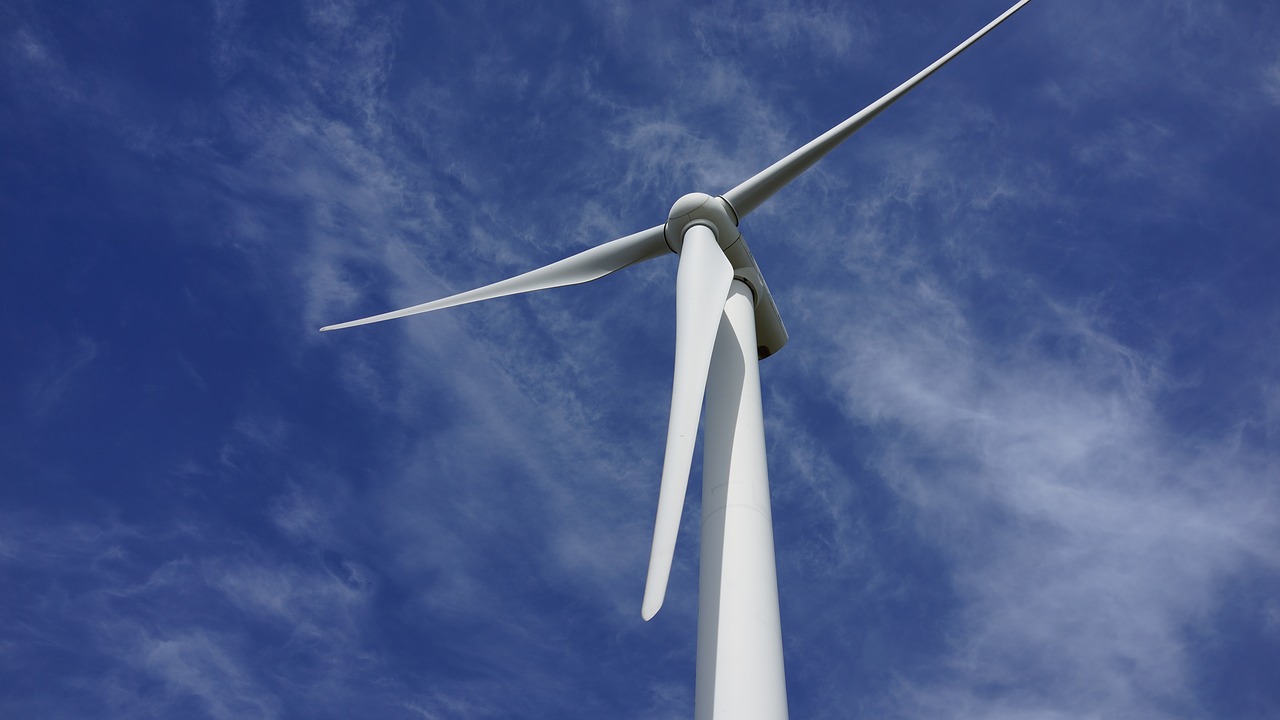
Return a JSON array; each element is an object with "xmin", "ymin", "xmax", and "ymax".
[{"xmin": 320, "ymin": 0, "xmax": 1030, "ymax": 720}]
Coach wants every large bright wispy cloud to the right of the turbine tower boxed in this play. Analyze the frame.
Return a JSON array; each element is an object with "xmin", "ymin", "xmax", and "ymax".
[{"xmin": 788, "ymin": 239, "xmax": 1280, "ymax": 717}]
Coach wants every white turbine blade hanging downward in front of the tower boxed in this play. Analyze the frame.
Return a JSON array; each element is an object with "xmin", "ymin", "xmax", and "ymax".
[{"xmin": 640, "ymin": 225, "xmax": 733, "ymax": 620}]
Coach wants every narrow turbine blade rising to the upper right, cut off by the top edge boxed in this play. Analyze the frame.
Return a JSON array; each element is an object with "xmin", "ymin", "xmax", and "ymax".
[{"xmin": 722, "ymin": 0, "xmax": 1030, "ymax": 220}]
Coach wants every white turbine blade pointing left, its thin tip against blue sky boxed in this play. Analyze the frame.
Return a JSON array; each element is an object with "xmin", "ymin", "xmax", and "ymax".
[{"xmin": 320, "ymin": 225, "xmax": 671, "ymax": 332}]
